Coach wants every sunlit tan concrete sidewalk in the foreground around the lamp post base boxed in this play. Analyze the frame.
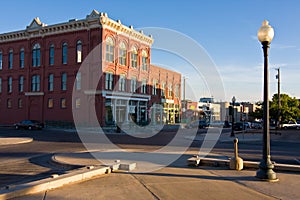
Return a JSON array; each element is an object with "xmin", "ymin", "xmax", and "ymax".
[{"xmin": 10, "ymin": 167, "xmax": 300, "ymax": 200}]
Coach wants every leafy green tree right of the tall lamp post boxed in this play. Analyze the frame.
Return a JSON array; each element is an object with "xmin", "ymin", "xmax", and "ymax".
[{"xmin": 270, "ymin": 94, "xmax": 300, "ymax": 122}]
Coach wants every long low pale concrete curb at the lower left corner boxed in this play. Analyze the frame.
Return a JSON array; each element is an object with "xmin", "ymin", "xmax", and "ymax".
[{"xmin": 0, "ymin": 167, "xmax": 111, "ymax": 200}]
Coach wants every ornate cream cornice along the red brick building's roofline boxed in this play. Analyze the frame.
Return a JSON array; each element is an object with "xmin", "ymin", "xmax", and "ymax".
[{"xmin": 0, "ymin": 10, "xmax": 153, "ymax": 46}]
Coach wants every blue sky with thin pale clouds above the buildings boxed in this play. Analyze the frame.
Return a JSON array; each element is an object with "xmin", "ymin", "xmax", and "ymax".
[{"xmin": 0, "ymin": 0, "xmax": 300, "ymax": 102}]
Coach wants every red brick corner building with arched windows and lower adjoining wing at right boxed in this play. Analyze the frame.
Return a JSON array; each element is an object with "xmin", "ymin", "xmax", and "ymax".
[{"xmin": 0, "ymin": 10, "xmax": 181, "ymax": 126}]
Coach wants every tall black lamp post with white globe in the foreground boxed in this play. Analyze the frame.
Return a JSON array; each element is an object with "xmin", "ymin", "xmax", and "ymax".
[{"xmin": 256, "ymin": 20, "xmax": 278, "ymax": 181}]
